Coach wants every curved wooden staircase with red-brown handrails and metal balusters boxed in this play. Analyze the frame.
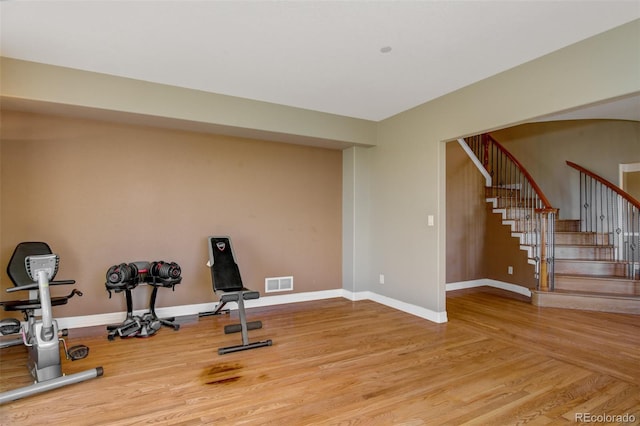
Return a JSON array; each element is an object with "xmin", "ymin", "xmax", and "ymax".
[{"xmin": 459, "ymin": 135, "xmax": 640, "ymax": 314}]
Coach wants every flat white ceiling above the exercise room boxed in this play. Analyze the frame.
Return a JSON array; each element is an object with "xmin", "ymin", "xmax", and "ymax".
[{"xmin": 0, "ymin": 0, "xmax": 640, "ymax": 121}]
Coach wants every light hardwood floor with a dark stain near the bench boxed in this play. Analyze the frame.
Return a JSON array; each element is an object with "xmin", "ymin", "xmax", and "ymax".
[{"xmin": 0, "ymin": 287, "xmax": 640, "ymax": 426}]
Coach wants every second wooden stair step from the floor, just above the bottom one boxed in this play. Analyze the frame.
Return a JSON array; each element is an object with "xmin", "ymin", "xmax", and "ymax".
[{"xmin": 554, "ymin": 274, "xmax": 640, "ymax": 296}]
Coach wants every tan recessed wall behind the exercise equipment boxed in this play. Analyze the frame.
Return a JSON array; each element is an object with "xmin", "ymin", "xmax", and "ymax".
[{"xmin": 0, "ymin": 110, "xmax": 342, "ymax": 317}]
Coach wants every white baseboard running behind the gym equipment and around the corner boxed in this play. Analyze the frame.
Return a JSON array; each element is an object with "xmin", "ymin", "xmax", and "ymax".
[{"xmin": 56, "ymin": 288, "xmax": 447, "ymax": 329}]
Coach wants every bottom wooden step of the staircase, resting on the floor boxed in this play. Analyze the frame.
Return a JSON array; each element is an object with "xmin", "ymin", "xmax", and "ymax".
[{"xmin": 531, "ymin": 290, "xmax": 640, "ymax": 315}]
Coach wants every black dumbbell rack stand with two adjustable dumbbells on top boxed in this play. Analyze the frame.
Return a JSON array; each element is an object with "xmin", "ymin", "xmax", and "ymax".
[{"xmin": 105, "ymin": 262, "xmax": 182, "ymax": 340}]
